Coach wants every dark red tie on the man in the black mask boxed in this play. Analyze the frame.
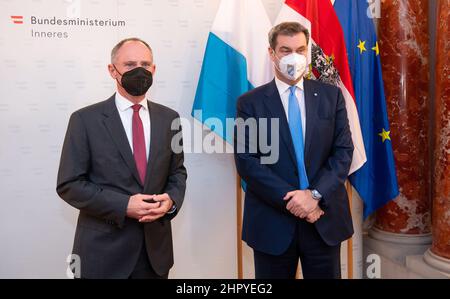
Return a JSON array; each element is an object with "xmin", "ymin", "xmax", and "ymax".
[{"xmin": 132, "ymin": 104, "xmax": 147, "ymax": 184}]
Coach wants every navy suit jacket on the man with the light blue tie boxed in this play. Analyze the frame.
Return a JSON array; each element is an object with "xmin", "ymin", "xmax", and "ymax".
[{"xmin": 234, "ymin": 79, "xmax": 353, "ymax": 255}]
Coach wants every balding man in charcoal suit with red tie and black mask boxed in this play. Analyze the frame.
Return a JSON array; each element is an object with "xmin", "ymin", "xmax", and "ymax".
[{"xmin": 56, "ymin": 38, "xmax": 187, "ymax": 278}]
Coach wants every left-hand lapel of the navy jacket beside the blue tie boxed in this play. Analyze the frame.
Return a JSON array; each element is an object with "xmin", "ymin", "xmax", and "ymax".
[{"xmin": 264, "ymin": 79, "xmax": 297, "ymax": 168}]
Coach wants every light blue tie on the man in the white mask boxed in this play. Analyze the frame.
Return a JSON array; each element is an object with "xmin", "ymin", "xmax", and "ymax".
[{"xmin": 288, "ymin": 85, "xmax": 309, "ymax": 190}]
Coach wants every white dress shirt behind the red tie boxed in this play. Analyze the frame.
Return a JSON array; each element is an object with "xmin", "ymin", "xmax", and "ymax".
[{"xmin": 116, "ymin": 92, "xmax": 150, "ymax": 161}]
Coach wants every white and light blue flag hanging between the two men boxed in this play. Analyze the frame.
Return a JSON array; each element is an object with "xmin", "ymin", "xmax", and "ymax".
[{"xmin": 192, "ymin": 0, "xmax": 273, "ymax": 144}]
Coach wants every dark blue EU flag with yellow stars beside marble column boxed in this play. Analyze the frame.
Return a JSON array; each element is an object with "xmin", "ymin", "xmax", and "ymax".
[{"xmin": 334, "ymin": 0, "xmax": 399, "ymax": 218}]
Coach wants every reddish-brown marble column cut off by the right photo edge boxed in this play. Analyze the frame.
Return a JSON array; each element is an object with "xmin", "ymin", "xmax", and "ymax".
[{"xmin": 424, "ymin": 0, "xmax": 450, "ymax": 273}]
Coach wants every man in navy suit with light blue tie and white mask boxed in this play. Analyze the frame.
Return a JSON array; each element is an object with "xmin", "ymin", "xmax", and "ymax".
[{"xmin": 235, "ymin": 22, "xmax": 353, "ymax": 278}]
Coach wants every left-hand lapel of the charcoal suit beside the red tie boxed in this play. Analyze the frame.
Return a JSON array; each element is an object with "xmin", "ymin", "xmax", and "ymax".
[{"xmin": 103, "ymin": 95, "xmax": 142, "ymax": 186}]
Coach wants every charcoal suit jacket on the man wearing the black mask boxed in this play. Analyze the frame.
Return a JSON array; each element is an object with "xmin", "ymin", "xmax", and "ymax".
[{"xmin": 56, "ymin": 95, "xmax": 187, "ymax": 278}]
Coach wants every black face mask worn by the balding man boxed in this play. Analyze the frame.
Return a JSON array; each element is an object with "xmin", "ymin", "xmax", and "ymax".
[{"xmin": 114, "ymin": 65, "xmax": 153, "ymax": 97}]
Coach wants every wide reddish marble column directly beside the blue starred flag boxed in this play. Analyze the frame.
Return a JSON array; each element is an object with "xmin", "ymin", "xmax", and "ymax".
[{"xmin": 370, "ymin": 0, "xmax": 431, "ymax": 244}]
